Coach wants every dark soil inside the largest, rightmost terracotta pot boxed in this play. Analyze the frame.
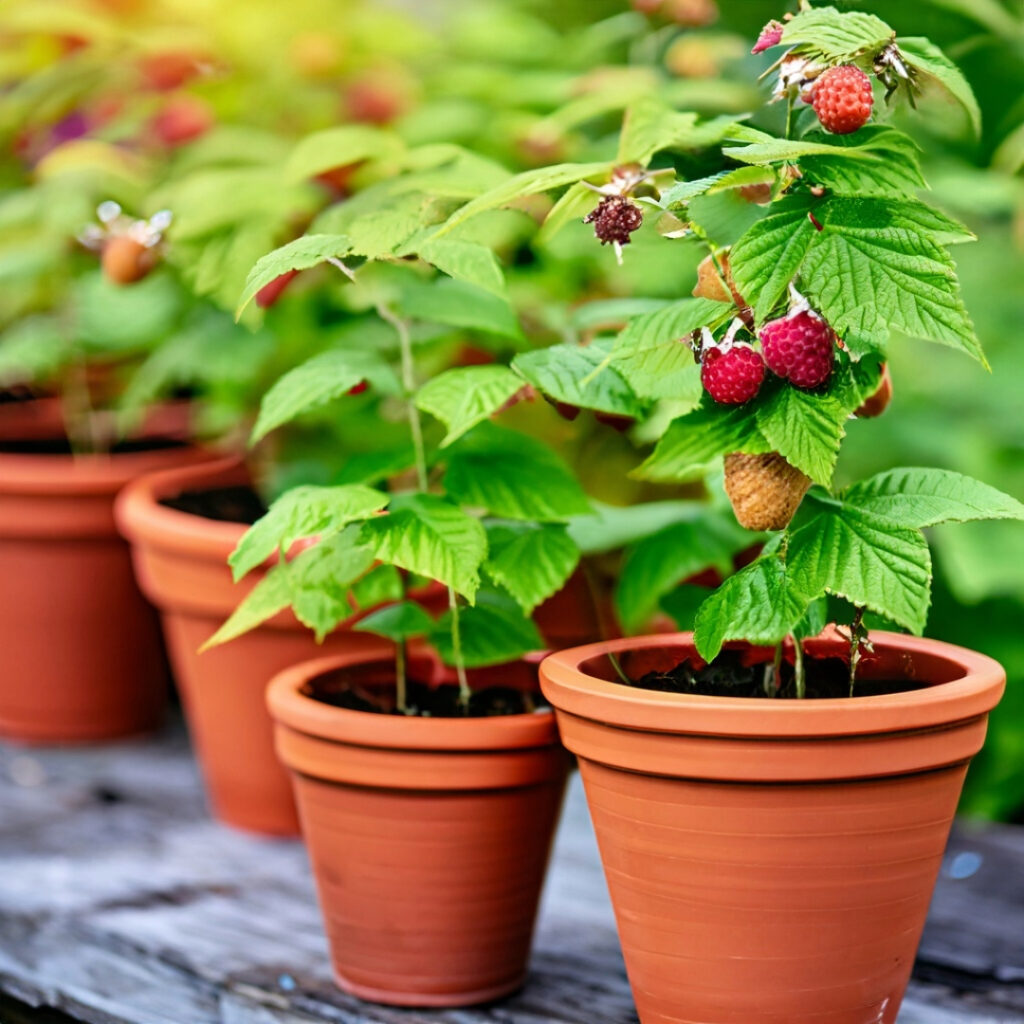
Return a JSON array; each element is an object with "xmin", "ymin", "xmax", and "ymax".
[{"xmin": 631, "ymin": 650, "xmax": 929, "ymax": 700}]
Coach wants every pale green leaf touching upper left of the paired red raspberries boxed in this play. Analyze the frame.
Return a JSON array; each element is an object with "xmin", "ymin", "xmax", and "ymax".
[{"xmin": 611, "ymin": 299, "xmax": 733, "ymax": 401}]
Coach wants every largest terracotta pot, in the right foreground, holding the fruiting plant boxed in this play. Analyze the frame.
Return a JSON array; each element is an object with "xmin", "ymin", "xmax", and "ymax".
[{"xmin": 541, "ymin": 633, "xmax": 1005, "ymax": 1024}]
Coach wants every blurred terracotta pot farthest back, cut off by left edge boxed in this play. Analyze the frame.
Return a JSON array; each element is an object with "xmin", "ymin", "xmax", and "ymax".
[{"xmin": 0, "ymin": 415, "xmax": 211, "ymax": 742}]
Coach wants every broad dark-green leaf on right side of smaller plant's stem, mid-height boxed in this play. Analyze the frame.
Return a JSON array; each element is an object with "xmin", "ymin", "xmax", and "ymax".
[{"xmin": 444, "ymin": 424, "xmax": 590, "ymax": 522}]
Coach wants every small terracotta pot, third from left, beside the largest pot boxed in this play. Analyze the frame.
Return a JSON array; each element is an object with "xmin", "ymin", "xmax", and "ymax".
[{"xmin": 267, "ymin": 656, "xmax": 567, "ymax": 1007}]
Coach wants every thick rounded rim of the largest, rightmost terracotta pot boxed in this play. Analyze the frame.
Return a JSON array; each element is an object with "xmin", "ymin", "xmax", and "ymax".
[{"xmin": 541, "ymin": 631, "xmax": 1006, "ymax": 738}]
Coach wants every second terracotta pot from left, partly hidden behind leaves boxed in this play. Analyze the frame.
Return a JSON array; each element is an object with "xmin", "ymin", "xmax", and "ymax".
[{"xmin": 117, "ymin": 459, "xmax": 391, "ymax": 836}]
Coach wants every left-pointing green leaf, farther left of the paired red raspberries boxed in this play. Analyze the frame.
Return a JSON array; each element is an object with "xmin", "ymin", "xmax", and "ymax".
[{"xmin": 512, "ymin": 339, "xmax": 646, "ymax": 418}]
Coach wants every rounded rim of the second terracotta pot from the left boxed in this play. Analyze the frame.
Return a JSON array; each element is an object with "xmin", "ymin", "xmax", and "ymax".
[{"xmin": 114, "ymin": 455, "xmax": 249, "ymax": 563}]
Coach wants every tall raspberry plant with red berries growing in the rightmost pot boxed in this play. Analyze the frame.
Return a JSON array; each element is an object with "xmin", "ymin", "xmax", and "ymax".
[{"xmin": 436, "ymin": 3, "xmax": 1024, "ymax": 694}]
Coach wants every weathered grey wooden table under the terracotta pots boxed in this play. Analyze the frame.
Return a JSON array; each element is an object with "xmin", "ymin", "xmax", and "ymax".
[{"xmin": 0, "ymin": 728, "xmax": 1024, "ymax": 1024}]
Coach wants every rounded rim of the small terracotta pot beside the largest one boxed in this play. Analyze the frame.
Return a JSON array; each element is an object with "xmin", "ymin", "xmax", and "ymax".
[{"xmin": 266, "ymin": 654, "xmax": 558, "ymax": 751}]
